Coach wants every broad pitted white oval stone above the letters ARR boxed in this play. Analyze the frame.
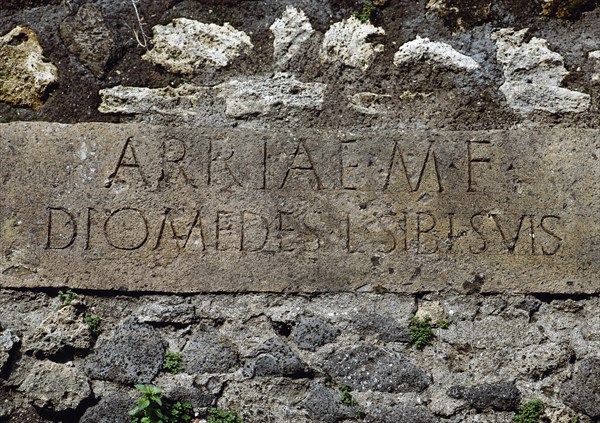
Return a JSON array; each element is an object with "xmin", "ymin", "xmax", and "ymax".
[{"xmin": 142, "ymin": 18, "xmax": 253, "ymax": 75}]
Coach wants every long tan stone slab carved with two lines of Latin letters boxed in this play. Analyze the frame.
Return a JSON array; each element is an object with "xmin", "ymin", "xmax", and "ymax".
[{"xmin": 0, "ymin": 123, "xmax": 600, "ymax": 293}]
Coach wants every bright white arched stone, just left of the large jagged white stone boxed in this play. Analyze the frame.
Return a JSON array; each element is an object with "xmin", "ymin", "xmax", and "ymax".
[{"xmin": 394, "ymin": 35, "xmax": 479, "ymax": 71}]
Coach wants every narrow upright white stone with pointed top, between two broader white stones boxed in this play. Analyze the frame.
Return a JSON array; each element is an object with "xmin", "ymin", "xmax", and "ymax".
[{"xmin": 269, "ymin": 6, "xmax": 315, "ymax": 68}]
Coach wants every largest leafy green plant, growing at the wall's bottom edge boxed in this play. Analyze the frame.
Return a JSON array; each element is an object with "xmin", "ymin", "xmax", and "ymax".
[{"xmin": 129, "ymin": 385, "xmax": 194, "ymax": 423}]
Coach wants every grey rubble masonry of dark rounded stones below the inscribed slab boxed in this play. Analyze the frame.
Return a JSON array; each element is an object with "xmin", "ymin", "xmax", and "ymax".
[{"xmin": 0, "ymin": 290, "xmax": 600, "ymax": 423}]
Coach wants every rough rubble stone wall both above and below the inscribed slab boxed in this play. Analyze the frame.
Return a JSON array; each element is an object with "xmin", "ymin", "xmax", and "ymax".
[{"xmin": 0, "ymin": 0, "xmax": 600, "ymax": 423}]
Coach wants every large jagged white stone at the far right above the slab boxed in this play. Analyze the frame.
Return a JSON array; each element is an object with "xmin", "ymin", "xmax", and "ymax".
[{"xmin": 492, "ymin": 28, "xmax": 590, "ymax": 114}]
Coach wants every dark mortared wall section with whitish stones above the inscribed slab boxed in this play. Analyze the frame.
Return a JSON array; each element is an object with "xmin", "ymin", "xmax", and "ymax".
[{"xmin": 0, "ymin": 0, "xmax": 600, "ymax": 129}]
